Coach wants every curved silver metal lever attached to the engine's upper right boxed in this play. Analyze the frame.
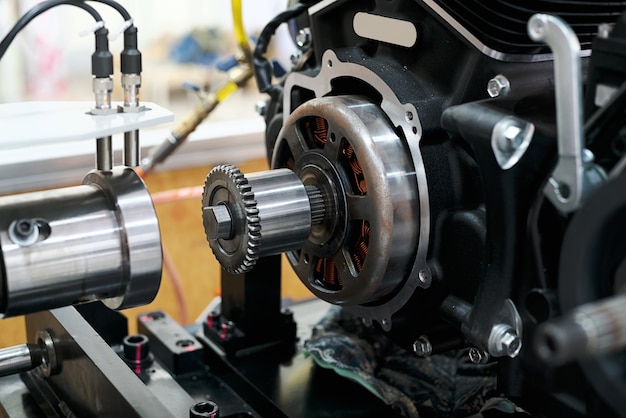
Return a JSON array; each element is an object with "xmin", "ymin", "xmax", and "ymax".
[{"xmin": 528, "ymin": 14, "xmax": 605, "ymax": 213}]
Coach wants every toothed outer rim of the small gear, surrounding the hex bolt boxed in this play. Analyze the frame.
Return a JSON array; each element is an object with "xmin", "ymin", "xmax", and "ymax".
[{"xmin": 202, "ymin": 164, "xmax": 262, "ymax": 274}]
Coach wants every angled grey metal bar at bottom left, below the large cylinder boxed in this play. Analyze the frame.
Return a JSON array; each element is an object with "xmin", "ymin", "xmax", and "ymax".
[{"xmin": 26, "ymin": 307, "xmax": 190, "ymax": 417}]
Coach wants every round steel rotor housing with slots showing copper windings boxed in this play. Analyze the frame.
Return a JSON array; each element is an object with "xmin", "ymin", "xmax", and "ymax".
[{"xmin": 272, "ymin": 96, "xmax": 419, "ymax": 307}]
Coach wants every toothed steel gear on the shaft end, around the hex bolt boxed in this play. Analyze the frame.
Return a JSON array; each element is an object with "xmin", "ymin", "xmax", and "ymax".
[{"xmin": 202, "ymin": 164, "xmax": 261, "ymax": 274}]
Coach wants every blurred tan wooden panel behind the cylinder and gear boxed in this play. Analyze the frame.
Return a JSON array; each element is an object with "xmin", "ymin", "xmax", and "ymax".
[{"xmin": 0, "ymin": 159, "xmax": 312, "ymax": 347}]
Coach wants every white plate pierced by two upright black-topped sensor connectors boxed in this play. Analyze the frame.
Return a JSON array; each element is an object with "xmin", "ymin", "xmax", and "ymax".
[{"xmin": 0, "ymin": 102, "xmax": 174, "ymax": 149}]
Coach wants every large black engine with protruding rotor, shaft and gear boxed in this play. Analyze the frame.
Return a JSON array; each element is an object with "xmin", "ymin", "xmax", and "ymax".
[{"xmin": 203, "ymin": 0, "xmax": 626, "ymax": 416}]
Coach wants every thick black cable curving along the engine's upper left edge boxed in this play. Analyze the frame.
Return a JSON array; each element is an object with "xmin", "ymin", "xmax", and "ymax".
[{"xmin": 252, "ymin": 4, "xmax": 308, "ymax": 95}]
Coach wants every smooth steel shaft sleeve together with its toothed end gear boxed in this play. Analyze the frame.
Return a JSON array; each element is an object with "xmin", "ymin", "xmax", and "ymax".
[{"xmin": 202, "ymin": 165, "xmax": 317, "ymax": 273}]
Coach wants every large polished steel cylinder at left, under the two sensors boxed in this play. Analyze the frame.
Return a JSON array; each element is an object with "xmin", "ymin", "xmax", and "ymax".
[{"xmin": 0, "ymin": 167, "xmax": 162, "ymax": 317}]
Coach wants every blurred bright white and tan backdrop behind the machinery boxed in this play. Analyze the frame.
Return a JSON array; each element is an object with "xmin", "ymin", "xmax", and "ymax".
[{"xmin": 0, "ymin": 0, "xmax": 310, "ymax": 347}]
